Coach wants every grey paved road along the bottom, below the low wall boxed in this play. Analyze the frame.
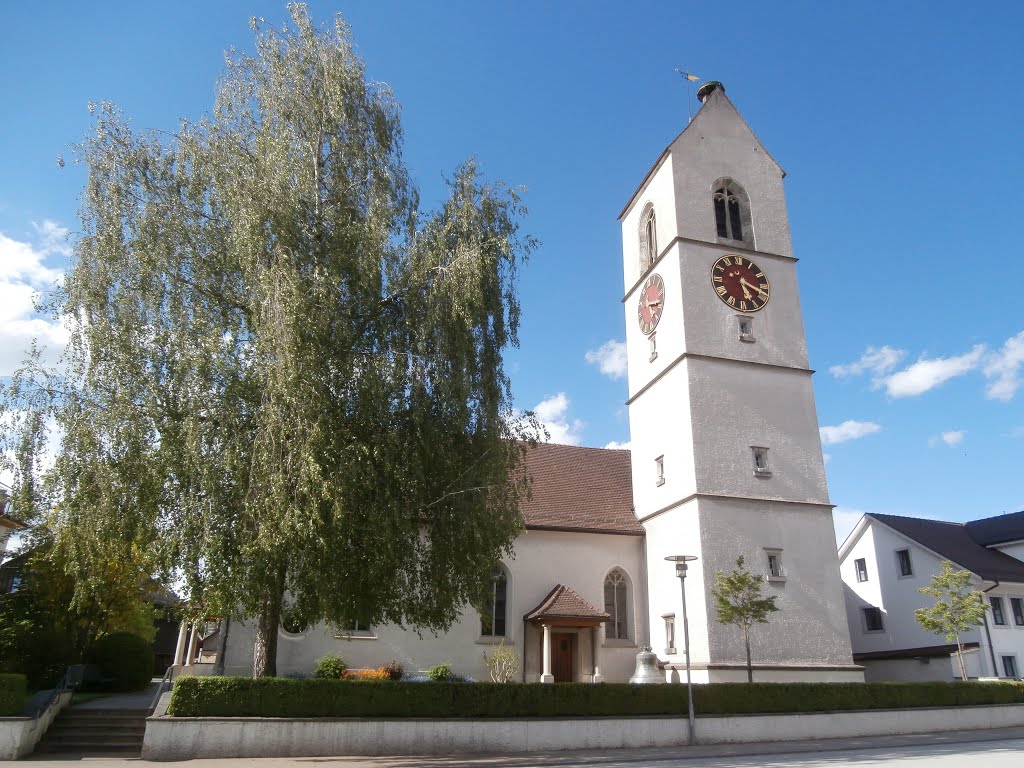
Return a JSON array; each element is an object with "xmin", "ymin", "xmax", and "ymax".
[{"xmin": 12, "ymin": 728, "xmax": 1024, "ymax": 768}]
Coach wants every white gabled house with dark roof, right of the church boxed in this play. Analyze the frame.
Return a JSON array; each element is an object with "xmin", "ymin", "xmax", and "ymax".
[{"xmin": 839, "ymin": 512, "xmax": 1024, "ymax": 680}]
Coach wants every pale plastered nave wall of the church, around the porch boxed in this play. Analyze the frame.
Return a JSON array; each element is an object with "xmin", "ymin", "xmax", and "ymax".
[{"xmin": 225, "ymin": 530, "xmax": 646, "ymax": 682}]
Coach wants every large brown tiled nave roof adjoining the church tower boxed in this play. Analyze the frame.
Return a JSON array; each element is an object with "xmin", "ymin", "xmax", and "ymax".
[{"xmin": 522, "ymin": 442, "xmax": 643, "ymax": 536}]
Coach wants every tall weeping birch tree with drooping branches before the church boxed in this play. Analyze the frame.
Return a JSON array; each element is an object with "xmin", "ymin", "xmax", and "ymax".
[{"xmin": 8, "ymin": 5, "xmax": 532, "ymax": 676}]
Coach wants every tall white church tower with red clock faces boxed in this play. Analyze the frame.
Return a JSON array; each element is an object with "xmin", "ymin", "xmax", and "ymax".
[{"xmin": 620, "ymin": 82, "xmax": 863, "ymax": 682}]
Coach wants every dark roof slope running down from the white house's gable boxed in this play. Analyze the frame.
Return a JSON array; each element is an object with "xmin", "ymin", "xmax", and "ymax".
[{"xmin": 867, "ymin": 513, "xmax": 1024, "ymax": 583}]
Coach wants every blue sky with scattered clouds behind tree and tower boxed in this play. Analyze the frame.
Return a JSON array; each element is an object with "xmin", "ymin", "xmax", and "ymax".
[{"xmin": 0, "ymin": 0, "xmax": 1024, "ymax": 531}]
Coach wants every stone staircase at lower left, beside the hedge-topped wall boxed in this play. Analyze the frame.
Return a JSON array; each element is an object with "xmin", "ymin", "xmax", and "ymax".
[{"xmin": 36, "ymin": 707, "xmax": 148, "ymax": 758}]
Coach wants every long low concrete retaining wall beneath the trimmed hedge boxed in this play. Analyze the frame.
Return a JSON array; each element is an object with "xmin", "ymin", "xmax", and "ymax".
[{"xmin": 142, "ymin": 705, "xmax": 1024, "ymax": 761}]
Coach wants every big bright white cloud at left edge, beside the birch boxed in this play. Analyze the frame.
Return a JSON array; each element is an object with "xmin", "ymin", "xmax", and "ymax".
[{"xmin": 0, "ymin": 227, "xmax": 70, "ymax": 376}]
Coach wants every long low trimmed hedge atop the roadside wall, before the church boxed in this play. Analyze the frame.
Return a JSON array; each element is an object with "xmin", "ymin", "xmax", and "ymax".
[{"xmin": 168, "ymin": 677, "xmax": 1024, "ymax": 718}]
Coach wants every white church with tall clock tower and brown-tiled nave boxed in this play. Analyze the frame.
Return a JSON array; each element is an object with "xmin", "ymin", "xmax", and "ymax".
[{"xmin": 211, "ymin": 82, "xmax": 863, "ymax": 683}]
